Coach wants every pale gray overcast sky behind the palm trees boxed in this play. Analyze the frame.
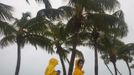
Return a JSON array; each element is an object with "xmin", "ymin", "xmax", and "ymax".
[{"xmin": 0, "ymin": 0, "xmax": 134, "ymax": 75}]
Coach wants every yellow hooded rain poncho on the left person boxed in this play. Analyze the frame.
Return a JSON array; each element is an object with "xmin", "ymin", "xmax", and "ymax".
[{"xmin": 44, "ymin": 58, "xmax": 58, "ymax": 75}]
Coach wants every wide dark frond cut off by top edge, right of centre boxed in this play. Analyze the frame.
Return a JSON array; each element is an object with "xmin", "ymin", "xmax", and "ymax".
[{"xmin": 69, "ymin": 0, "xmax": 120, "ymax": 12}]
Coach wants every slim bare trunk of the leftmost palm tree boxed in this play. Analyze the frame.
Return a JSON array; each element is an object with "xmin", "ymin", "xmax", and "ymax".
[{"xmin": 15, "ymin": 43, "xmax": 21, "ymax": 75}]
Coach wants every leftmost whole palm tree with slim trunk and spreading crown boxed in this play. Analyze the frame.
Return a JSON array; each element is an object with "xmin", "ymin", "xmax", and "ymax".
[{"xmin": 0, "ymin": 13, "xmax": 50, "ymax": 75}]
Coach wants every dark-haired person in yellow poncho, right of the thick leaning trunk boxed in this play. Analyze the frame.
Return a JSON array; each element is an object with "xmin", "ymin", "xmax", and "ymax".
[{"xmin": 73, "ymin": 59, "xmax": 84, "ymax": 75}]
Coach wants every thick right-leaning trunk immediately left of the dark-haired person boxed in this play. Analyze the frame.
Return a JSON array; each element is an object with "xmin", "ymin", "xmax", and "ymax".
[{"xmin": 68, "ymin": 45, "xmax": 76, "ymax": 75}]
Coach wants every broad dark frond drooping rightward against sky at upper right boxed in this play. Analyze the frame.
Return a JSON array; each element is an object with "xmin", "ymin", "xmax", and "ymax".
[{"xmin": 87, "ymin": 13, "xmax": 128, "ymax": 37}]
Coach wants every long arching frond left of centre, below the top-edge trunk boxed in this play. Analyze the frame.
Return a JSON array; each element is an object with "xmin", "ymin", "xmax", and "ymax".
[{"xmin": 37, "ymin": 6, "xmax": 73, "ymax": 20}]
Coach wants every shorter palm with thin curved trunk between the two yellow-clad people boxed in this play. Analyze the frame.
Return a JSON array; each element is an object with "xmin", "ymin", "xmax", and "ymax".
[{"xmin": 47, "ymin": 22, "xmax": 69, "ymax": 75}]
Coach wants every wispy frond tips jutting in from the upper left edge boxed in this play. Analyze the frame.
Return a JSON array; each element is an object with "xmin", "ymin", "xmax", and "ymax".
[{"xmin": 0, "ymin": 3, "xmax": 13, "ymax": 20}]
